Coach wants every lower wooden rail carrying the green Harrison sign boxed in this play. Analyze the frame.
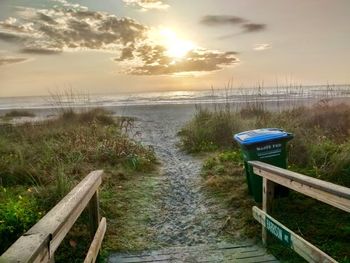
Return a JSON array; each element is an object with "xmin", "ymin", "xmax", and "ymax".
[{"xmin": 253, "ymin": 206, "xmax": 337, "ymax": 263}]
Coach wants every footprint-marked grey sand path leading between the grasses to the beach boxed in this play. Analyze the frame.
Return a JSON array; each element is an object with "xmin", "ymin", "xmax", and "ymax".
[{"xmin": 119, "ymin": 106, "xmax": 226, "ymax": 246}]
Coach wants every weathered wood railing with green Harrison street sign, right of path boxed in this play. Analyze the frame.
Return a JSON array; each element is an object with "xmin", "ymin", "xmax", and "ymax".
[{"xmin": 249, "ymin": 161, "xmax": 350, "ymax": 263}]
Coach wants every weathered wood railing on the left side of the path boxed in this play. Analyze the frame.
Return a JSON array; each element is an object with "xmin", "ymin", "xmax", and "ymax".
[{"xmin": 0, "ymin": 171, "xmax": 106, "ymax": 263}]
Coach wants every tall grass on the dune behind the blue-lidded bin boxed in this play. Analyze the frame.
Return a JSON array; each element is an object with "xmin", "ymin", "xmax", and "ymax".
[{"xmin": 179, "ymin": 102, "xmax": 350, "ymax": 186}]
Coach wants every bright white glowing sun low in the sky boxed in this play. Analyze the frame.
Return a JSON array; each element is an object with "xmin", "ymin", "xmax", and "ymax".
[{"xmin": 158, "ymin": 28, "xmax": 196, "ymax": 59}]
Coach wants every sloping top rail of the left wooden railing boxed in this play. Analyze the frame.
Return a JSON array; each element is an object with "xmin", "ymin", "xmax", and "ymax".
[{"xmin": 0, "ymin": 171, "xmax": 103, "ymax": 262}]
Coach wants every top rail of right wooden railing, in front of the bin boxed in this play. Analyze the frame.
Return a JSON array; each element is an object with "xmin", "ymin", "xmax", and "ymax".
[{"xmin": 250, "ymin": 161, "xmax": 350, "ymax": 212}]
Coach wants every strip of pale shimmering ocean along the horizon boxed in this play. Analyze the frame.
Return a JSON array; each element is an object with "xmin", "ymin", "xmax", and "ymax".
[{"xmin": 0, "ymin": 85, "xmax": 350, "ymax": 110}]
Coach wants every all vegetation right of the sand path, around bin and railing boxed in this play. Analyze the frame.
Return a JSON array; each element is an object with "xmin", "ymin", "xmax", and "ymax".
[{"xmin": 179, "ymin": 101, "xmax": 350, "ymax": 262}]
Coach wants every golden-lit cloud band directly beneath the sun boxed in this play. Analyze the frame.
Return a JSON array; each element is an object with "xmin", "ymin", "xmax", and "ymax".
[{"xmin": 117, "ymin": 45, "xmax": 239, "ymax": 75}]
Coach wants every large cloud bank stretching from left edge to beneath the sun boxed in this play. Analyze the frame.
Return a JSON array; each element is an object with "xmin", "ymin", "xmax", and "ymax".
[{"xmin": 0, "ymin": 4, "xmax": 239, "ymax": 75}]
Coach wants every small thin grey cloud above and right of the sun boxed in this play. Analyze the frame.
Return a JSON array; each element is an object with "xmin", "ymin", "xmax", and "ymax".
[{"xmin": 200, "ymin": 15, "xmax": 266, "ymax": 35}]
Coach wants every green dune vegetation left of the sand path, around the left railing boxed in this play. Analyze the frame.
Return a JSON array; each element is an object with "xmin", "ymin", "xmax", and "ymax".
[{"xmin": 0, "ymin": 109, "xmax": 156, "ymax": 262}]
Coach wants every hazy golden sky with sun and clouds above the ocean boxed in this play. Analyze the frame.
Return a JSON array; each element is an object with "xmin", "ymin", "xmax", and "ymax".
[{"xmin": 0, "ymin": 0, "xmax": 350, "ymax": 97}]
